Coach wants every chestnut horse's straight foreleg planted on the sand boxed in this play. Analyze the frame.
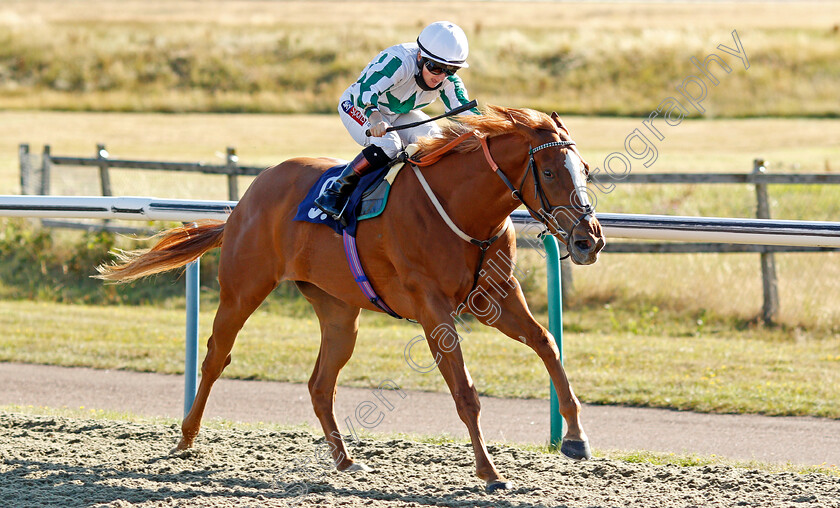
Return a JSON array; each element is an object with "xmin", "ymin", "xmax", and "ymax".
[{"xmin": 420, "ymin": 307, "xmax": 512, "ymax": 492}]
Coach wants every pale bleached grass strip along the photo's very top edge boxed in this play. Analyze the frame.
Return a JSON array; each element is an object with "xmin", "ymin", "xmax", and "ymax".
[{"xmin": 0, "ymin": 0, "xmax": 828, "ymax": 29}]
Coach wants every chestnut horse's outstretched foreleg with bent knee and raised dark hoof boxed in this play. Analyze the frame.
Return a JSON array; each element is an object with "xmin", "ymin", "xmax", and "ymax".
[{"xmin": 468, "ymin": 278, "xmax": 590, "ymax": 459}]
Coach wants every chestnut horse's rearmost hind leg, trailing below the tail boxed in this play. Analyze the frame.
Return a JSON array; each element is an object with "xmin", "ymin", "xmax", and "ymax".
[{"xmin": 177, "ymin": 264, "xmax": 276, "ymax": 450}]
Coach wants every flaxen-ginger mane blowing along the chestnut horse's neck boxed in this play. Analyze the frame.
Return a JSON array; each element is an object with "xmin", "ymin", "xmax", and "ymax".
[{"xmin": 417, "ymin": 104, "xmax": 555, "ymax": 157}]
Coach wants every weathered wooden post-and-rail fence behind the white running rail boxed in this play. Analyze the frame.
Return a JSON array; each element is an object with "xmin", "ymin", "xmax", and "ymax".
[{"xmin": 14, "ymin": 144, "xmax": 840, "ymax": 322}]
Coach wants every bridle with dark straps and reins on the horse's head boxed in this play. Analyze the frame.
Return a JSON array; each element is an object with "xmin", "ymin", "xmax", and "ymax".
[{"xmin": 480, "ymin": 136, "xmax": 592, "ymax": 259}]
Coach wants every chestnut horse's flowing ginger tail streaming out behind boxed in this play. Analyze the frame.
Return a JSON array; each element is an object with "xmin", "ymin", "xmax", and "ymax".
[{"xmin": 94, "ymin": 220, "xmax": 225, "ymax": 282}]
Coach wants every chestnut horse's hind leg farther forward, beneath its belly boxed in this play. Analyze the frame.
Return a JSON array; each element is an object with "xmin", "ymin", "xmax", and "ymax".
[{"xmin": 296, "ymin": 282, "xmax": 367, "ymax": 471}]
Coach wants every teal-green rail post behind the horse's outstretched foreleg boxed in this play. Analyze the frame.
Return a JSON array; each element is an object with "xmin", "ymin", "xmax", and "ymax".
[{"xmin": 543, "ymin": 235, "xmax": 564, "ymax": 450}]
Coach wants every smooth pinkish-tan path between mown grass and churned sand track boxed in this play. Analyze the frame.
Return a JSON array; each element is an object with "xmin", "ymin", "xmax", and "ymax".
[{"xmin": 0, "ymin": 363, "xmax": 840, "ymax": 465}]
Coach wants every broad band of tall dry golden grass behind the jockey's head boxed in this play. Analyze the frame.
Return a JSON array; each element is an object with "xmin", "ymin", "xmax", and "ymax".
[{"xmin": 0, "ymin": 0, "xmax": 840, "ymax": 117}]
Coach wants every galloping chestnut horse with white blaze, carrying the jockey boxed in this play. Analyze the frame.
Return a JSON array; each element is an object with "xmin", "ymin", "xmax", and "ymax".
[{"xmin": 98, "ymin": 105, "xmax": 605, "ymax": 492}]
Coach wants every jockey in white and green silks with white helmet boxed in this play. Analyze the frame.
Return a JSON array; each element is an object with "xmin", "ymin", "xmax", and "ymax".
[{"xmin": 315, "ymin": 21, "xmax": 479, "ymax": 221}]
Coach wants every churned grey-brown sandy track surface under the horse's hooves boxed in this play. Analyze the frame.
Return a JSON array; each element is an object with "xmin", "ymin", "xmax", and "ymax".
[{"xmin": 0, "ymin": 413, "xmax": 840, "ymax": 508}]
